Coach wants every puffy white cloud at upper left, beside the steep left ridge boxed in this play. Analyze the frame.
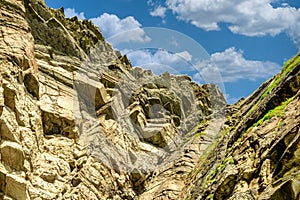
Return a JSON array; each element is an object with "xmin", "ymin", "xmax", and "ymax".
[{"xmin": 91, "ymin": 13, "xmax": 150, "ymax": 42}]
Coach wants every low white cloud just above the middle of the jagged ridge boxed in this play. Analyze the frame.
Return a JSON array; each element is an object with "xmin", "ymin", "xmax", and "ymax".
[{"xmin": 122, "ymin": 50, "xmax": 192, "ymax": 75}]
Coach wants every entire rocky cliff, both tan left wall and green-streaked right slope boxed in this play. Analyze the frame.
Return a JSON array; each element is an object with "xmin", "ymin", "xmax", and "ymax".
[{"xmin": 0, "ymin": 0, "xmax": 300, "ymax": 199}]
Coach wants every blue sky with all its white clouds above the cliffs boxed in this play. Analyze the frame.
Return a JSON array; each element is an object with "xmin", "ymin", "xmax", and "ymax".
[{"xmin": 46, "ymin": 0, "xmax": 300, "ymax": 103}]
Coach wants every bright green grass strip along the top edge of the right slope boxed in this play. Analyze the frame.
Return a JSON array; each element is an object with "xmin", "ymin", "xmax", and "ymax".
[{"xmin": 260, "ymin": 53, "xmax": 300, "ymax": 99}]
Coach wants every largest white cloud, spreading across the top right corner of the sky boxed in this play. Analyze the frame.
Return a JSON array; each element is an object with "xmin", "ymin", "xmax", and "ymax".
[{"xmin": 166, "ymin": 0, "xmax": 300, "ymax": 48}]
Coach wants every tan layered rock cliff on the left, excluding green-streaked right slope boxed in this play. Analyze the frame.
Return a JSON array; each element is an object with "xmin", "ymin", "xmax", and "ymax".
[{"xmin": 0, "ymin": 0, "xmax": 225, "ymax": 199}]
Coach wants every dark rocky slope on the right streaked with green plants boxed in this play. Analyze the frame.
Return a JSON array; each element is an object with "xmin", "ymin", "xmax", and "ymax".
[{"xmin": 183, "ymin": 54, "xmax": 300, "ymax": 200}]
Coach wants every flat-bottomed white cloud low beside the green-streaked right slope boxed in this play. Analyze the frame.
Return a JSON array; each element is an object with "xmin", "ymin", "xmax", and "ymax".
[{"xmin": 194, "ymin": 47, "xmax": 280, "ymax": 82}]
